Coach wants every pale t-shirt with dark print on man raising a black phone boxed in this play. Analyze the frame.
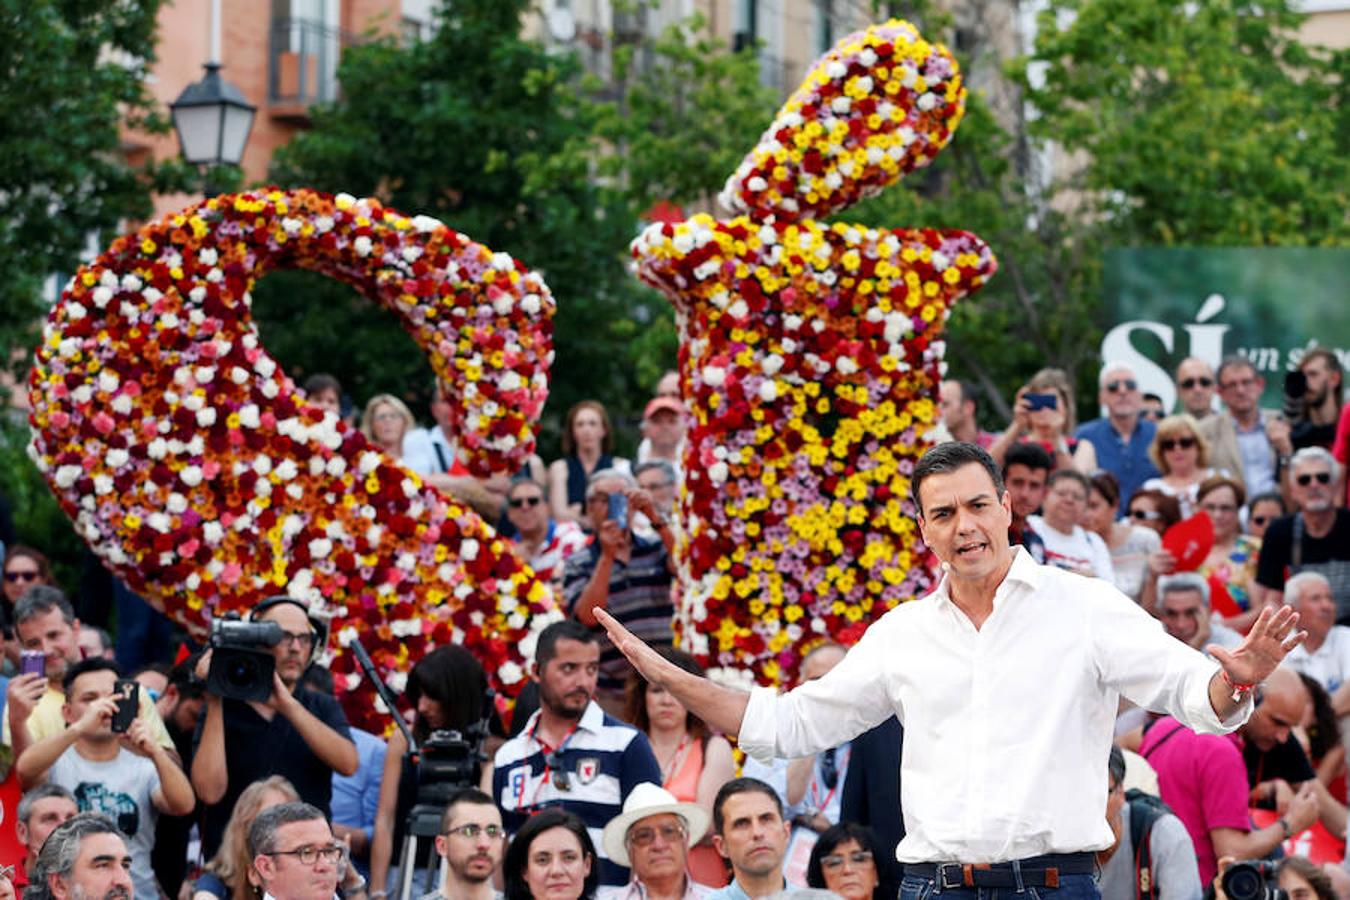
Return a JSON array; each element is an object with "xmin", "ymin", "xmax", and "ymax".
[{"xmin": 47, "ymin": 748, "xmax": 159, "ymax": 897}]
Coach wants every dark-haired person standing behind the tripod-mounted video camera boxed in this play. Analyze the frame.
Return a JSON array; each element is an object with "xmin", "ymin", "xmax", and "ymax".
[{"xmin": 370, "ymin": 644, "xmax": 487, "ymax": 900}]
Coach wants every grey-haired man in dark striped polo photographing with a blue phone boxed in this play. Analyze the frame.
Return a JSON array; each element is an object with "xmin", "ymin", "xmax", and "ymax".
[{"xmin": 563, "ymin": 468, "xmax": 675, "ymax": 715}]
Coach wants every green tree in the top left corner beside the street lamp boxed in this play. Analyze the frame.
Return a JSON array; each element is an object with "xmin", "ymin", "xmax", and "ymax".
[{"xmin": 0, "ymin": 0, "xmax": 179, "ymax": 362}]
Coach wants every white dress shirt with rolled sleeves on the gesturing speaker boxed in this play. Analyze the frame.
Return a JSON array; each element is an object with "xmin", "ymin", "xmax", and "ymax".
[{"xmin": 740, "ymin": 548, "xmax": 1251, "ymax": 862}]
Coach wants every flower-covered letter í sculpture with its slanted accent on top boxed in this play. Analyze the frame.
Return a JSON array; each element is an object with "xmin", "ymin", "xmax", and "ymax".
[{"xmin": 633, "ymin": 20, "xmax": 995, "ymax": 684}]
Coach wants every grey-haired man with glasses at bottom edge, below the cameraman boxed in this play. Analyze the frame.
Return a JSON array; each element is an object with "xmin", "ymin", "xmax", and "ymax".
[{"xmin": 248, "ymin": 803, "xmax": 351, "ymax": 900}]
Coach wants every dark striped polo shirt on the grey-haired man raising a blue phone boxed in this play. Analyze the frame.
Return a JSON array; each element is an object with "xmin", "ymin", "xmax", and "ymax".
[{"xmin": 563, "ymin": 534, "xmax": 675, "ymax": 691}]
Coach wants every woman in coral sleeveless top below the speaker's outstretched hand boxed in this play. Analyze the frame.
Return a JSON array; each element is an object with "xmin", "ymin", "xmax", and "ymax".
[{"xmin": 624, "ymin": 648, "xmax": 736, "ymax": 888}]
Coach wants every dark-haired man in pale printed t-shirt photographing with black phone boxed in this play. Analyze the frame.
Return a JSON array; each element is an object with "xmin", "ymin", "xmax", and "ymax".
[{"xmin": 15, "ymin": 657, "xmax": 196, "ymax": 897}]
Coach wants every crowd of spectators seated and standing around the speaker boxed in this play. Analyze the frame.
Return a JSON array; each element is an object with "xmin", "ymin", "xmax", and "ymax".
[{"xmin": 0, "ymin": 351, "xmax": 1350, "ymax": 900}]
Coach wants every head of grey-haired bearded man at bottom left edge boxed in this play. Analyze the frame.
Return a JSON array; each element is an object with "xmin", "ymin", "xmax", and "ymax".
[{"xmin": 23, "ymin": 812, "xmax": 135, "ymax": 900}]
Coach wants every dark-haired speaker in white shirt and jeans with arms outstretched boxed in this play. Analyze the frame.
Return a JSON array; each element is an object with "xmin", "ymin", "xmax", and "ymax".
[{"xmin": 598, "ymin": 443, "xmax": 1303, "ymax": 900}]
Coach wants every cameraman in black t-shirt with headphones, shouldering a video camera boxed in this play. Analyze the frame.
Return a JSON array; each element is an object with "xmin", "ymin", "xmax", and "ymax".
[{"xmin": 192, "ymin": 595, "xmax": 359, "ymax": 858}]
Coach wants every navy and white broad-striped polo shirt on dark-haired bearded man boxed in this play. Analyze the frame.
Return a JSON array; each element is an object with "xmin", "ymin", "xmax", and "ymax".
[{"xmin": 493, "ymin": 700, "xmax": 662, "ymax": 887}]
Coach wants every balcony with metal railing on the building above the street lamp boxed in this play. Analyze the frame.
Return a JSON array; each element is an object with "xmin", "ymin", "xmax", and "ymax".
[{"xmin": 267, "ymin": 19, "xmax": 352, "ymax": 116}]
